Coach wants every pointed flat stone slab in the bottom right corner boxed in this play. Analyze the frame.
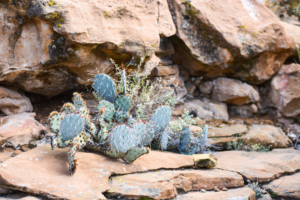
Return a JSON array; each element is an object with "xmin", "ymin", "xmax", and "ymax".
[{"xmin": 264, "ymin": 173, "xmax": 300, "ymax": 199}]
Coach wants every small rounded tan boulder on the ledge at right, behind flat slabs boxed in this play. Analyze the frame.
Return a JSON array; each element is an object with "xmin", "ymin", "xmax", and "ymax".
[{"xmin": 244, "ymin": 125, "xmax": 293, "ymax": 148}]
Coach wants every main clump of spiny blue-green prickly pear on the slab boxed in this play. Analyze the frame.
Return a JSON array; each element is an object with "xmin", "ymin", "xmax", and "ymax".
[{"xmin": 49, "ymin": 71, "xmax": 180, "ymax": 174}]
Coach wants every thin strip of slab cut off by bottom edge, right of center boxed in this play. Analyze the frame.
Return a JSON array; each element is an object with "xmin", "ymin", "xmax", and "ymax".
[{"xmin": 176, "ymin": 187, "xmax": 256, "ymax": 200}]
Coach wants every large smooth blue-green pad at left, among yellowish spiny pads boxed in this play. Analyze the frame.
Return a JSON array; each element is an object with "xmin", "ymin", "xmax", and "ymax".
[{"xmin": 59, "ymin": 114, "xmax": 85, "ymax": 141}]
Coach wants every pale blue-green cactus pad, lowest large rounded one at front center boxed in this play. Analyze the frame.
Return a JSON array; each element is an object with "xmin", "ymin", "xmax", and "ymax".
[{"xmin": 110, "ymin": 125, "xmax": 133, "ymax": 153}]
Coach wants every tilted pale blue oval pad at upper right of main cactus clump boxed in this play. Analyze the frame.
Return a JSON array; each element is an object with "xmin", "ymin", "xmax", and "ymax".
[{"xmin": 150, "ymin": 106, "xmax": 172, "ymax": 133}]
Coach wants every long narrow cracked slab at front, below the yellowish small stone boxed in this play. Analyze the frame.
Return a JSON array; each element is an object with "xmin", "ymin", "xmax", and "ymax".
[{"xmin": 108, "ymin": 169, "xmax": 244, "ymax": 199}]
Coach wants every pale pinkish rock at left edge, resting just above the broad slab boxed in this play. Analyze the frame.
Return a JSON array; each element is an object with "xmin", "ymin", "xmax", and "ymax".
[{"xmin": 0, "ymin": 113, "xmax": 46, "ymax": 148}]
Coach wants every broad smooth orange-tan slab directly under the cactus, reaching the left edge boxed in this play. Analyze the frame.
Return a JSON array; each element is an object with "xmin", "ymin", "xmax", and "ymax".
[{"xmin": 0, "ymin": 145, "xmax": 194, "ymax": 199}]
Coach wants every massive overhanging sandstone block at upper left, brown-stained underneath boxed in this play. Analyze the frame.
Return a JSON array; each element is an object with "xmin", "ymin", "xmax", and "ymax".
[{"xmin": 0, "ymin": 0, "xmax": 176, "ymax": 97}]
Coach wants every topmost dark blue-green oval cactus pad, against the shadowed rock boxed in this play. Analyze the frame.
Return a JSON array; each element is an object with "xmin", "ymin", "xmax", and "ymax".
[{"xmin": 92, "ymin": 74, "xmax": 116, "ymax": 103}]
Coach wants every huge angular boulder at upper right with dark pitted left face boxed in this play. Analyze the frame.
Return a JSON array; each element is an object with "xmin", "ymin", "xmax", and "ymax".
[{"xmin": 169, "ymin": 0, "xmax": 294, "ymax": 84}]
